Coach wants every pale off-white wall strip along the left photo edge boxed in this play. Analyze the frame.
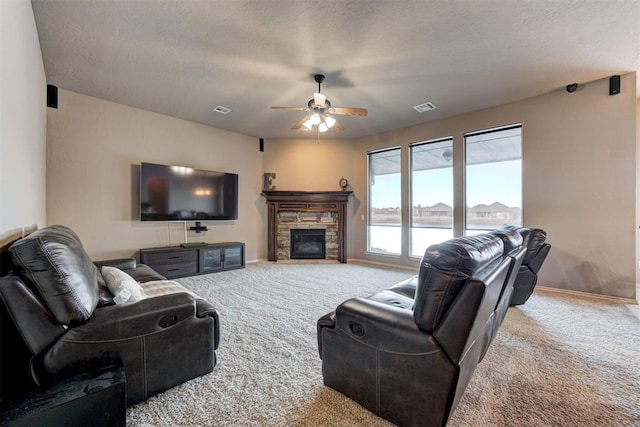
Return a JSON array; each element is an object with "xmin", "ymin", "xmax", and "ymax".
[{"xmin": 0, "ymin": 0, "xmax": 47, "ymax": 240}]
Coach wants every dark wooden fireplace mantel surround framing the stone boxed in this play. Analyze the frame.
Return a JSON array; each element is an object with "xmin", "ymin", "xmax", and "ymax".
[{"xmin": 262, "ymin": 190, "xmax": 352, "ymax": 263}]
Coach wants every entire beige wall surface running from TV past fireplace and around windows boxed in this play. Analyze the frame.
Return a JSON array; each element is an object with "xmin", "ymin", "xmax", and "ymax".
[{"xmin": 42, "ymin": 69, "xmax": 637, "ymax": 298}]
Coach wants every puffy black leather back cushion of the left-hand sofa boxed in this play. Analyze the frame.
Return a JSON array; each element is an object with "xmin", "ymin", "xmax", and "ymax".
[{"xmin": 9, "ymin": 225, "xmax": 98, "ymax": 325}]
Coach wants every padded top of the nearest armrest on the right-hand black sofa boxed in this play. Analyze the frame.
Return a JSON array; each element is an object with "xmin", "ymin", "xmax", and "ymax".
[{"xmin": 335, "ymin": 298, "xmax": 440, "ymax": 354}]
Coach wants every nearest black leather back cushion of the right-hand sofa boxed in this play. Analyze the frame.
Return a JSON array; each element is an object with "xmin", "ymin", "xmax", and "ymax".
[{"xmin": 413, "ymin": 234, "xmax": 504, "ymax": 332}]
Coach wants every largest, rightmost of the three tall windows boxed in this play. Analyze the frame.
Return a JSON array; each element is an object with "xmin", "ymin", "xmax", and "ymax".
[{"xmin": 465, "ymin": 125, "xmax": 522, "ymax": 235}]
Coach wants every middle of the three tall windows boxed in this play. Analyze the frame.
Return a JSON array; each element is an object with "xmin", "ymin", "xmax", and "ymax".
[{"xmin": 409, "ymin": 138, "xmax": 453, "ymax": 257}]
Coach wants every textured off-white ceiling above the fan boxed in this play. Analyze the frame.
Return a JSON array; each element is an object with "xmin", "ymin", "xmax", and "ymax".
[{"xmin": 32, "ymin": 0, "xmax": 640, "ymax": 139}]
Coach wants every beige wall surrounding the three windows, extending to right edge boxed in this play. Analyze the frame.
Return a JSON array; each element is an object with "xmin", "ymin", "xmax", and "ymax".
[{"xmin": 351, "ymin": 73, "xmax": 637, "ymax": 298}]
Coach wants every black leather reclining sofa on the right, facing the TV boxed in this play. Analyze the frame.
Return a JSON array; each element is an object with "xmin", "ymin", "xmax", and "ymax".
[{"xmin": 318, "ymin": 229, "xmax": 525, "ymax": 426}]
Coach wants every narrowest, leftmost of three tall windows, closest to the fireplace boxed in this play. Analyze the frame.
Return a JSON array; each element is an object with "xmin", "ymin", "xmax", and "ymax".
[{"xmin": 367, "ymin": 147, "xmax": 402, "ymax": 255}]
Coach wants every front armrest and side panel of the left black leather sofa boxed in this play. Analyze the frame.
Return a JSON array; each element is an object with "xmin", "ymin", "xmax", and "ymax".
[{"xmin": 42, "ymin": 293, "xmax": 215, "ymax": 404}]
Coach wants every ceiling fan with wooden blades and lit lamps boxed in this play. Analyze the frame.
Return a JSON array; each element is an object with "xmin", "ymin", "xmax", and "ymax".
[{"xmin": 271, "ymin": 74, "xmax": 368, "ymax": 132}]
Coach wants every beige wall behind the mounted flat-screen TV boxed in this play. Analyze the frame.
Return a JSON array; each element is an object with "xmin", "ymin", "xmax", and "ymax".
[{"xmin": 47, "ymin": 90, "xmax": 266, "ymax": 261}]
